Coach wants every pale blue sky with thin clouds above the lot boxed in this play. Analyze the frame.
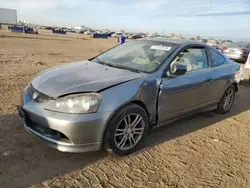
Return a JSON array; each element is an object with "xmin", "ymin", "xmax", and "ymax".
[{"xmin": 0, "ymin": 0, "xmax": 250, "ymax": 39}]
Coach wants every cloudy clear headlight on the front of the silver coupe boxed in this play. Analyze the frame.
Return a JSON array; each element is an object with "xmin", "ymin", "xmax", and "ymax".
[{"xmin": 45, "ymin": 93, "xmax": 101, "ymax": 114}]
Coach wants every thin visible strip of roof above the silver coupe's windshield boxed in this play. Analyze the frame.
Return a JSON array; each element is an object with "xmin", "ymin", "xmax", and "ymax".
[{"xmin": 137, "ymin": 37, "xmax": 208, "ymax": 46}]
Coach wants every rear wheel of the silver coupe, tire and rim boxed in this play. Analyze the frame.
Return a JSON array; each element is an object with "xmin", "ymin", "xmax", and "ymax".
[{"xmin": 216, "ymin": 85, "xmax": 235, "ymax": 114}]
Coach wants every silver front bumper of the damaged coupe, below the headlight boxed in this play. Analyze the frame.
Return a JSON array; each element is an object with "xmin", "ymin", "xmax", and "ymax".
[{"xmin": 18, "ymin": 92, "xmax": 111, "ymax": 153}]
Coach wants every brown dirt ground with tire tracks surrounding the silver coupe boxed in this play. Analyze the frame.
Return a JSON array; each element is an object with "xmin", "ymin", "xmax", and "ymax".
[{"xmin": 0, "ymin": 31, "xmax": 250, "ymax": 188}]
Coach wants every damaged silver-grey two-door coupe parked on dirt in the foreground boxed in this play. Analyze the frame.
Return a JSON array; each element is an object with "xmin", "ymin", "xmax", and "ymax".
[{"xmin": 18, "ymin": 38, "xmax": 240, "ymax": 155}]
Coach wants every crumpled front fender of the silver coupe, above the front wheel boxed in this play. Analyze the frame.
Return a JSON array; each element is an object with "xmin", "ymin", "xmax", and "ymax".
[{"xmin": 98, "ymin": 77, "xmax": 160, "ymax": 138}]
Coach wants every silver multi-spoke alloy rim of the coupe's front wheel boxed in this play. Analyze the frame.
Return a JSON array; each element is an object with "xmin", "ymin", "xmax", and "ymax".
[{"xmin": 114, "ymin": 114, "xmax": 145, "ymax": 150}]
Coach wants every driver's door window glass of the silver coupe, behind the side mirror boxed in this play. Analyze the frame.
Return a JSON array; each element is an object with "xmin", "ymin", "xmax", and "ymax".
[{"xmin": 170, "ymin": 47, "xmax": 208, "ymax": 71}]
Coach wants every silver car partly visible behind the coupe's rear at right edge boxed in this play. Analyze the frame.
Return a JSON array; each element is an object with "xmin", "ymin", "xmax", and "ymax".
[{"xmin": 222, "ymin": 42, "xmax": 250, "ymax": 63}]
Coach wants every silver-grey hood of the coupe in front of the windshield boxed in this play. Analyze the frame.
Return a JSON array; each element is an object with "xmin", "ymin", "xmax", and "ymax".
[{"xmin": 31, "ymin": 61, "xmax": 142, "ymax": 97}]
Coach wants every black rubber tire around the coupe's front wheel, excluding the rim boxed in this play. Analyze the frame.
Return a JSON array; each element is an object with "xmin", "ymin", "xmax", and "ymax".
[{"xmin": 103, "ymin": 104, "xmax": 149, "ymax": 156}]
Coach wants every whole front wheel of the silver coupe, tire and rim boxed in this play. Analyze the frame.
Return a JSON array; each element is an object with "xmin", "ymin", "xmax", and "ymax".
[{"xmin": 103, "ymin": 104, "xmax": 149, "ymax": 156}]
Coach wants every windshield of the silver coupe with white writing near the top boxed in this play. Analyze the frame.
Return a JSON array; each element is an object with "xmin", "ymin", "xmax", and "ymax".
[{"xmin": 95, "ymin": 41, "xmax": 177, "ymax": 73}]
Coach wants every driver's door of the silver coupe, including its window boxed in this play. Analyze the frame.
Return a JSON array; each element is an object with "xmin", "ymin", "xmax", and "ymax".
[{"xmin": 158, "ymin": 46, "xmax": 215, "ymax": 123}]
